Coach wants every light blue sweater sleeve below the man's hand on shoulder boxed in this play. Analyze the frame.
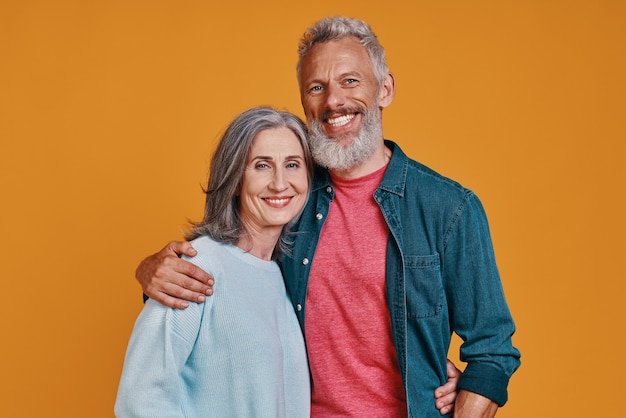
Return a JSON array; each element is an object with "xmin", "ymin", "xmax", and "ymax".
[{"xmin": 115, "ymin": 300, "xmax": 204, "ymax": 418}]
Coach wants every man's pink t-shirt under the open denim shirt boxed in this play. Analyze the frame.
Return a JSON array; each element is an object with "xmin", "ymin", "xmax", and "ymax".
[{"xmin": 305, "ymin": 167, "xmax": 407, "ymax": 417}]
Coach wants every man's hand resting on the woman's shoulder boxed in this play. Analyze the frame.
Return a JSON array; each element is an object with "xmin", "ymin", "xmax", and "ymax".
[{"xmin": 135, "ymin": 241, "xmax": 213, "ymax": 309}]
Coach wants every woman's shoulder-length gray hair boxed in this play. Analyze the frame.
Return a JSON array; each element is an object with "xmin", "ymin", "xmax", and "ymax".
[{"xmin": 185, "ymin": 106, "xmax": 313, "ymax": 258}]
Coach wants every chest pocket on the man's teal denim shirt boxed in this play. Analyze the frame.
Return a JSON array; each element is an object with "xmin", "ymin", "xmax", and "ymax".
[{"xmin": 404, "ymin": 254, "xmax": 444, "ymax": 318}]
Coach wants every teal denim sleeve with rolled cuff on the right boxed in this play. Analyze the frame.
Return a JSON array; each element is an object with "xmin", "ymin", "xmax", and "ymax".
[{"xmin": 443, "ymin": 191, "xmax": 520, "ymax": 406}]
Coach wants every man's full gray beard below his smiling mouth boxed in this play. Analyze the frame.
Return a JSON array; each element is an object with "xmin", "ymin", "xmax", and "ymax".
[{"xmin": 308, "ymin": 108, "xmax": 383, "ymax": 170}]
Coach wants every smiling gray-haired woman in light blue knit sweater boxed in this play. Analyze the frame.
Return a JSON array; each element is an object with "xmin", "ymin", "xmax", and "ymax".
[{"xmin": 115, "ymin": 107, "xmax": 313, "ymax": 418}]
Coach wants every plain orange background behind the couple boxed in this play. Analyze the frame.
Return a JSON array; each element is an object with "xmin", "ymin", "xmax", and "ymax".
[{"xmin": 0, "ymin": 0, "xmax": 626, "ymax": 417}]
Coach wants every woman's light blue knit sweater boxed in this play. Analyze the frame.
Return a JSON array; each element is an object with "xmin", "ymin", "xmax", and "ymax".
[{"xmin": 115, "ymin": 237, "xmax": 311, "ymax": 418}]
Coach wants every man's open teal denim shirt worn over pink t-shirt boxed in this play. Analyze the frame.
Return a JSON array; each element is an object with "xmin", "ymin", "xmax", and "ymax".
[{"xmin": 282, "ymin": 141, "xmax": 520, "ymax": 417}]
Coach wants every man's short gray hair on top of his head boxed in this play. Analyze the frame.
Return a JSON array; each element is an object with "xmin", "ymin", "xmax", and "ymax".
[{"xmin": 296, "ymin": 16, "xmax": 389, "ymax": 84}]
